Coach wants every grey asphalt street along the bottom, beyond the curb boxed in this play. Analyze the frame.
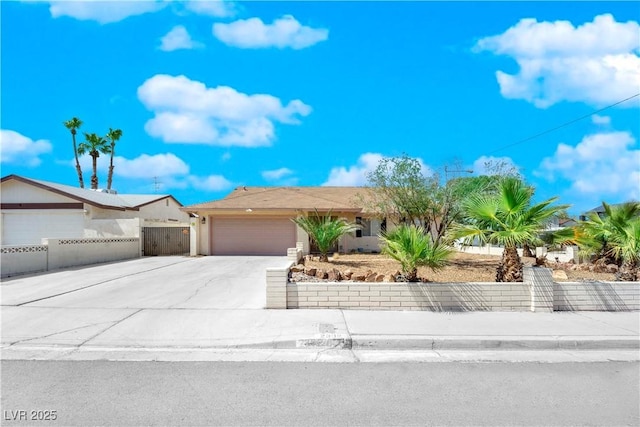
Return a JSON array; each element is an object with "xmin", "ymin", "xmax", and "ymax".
[{"xmin": 2, "ymin": 361, "xmax": 640, "ymax": 426}]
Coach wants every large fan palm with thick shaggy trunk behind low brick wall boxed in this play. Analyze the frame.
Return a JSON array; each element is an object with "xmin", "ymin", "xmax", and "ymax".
[{"xmin": 452, "ymin": 178, "xmax": 567, "ymax": 282}]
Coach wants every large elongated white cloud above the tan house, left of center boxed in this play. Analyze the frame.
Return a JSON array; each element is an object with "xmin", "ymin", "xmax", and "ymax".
[{"xmin": 138, "ymin": 74, "xmax": 311, "ymax": 147}]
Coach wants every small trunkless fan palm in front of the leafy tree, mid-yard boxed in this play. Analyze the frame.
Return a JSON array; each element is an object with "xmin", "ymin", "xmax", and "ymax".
[{"xmin": 381, "ymin": 224, "xmax": 452, "ymax": 282}]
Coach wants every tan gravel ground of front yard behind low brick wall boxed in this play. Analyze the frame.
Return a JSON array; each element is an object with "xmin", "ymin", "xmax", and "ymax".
[{"xmin": 291, "ymin": 252, "xmax": 615, "ymax": 283}]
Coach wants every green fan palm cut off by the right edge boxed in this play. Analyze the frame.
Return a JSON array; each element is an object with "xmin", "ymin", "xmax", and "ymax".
[{"xmin": 576, "ymin": 202, "xmax": 640, "ymax": 281}]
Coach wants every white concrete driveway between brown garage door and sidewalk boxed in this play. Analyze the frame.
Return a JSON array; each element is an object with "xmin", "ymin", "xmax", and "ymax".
[{"xmin": 1, "ymin": 256, "xmax": 286, "ymax": 309}]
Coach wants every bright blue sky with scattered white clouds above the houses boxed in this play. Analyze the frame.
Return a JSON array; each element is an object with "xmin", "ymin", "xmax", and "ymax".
[{"xmin": 0, "ymin": 1, "xmax": 640, "ymax": 213}]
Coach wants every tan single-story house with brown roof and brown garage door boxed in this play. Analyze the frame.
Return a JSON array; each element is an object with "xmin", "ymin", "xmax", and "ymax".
[{"xmin": 182, "ymin": 187, "xmax": 386, "ymax": 255}]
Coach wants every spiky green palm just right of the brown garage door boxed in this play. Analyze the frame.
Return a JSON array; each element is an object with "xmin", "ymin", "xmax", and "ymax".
[{"xmin": 291, "ymin": 209, "xmax": 360, "ymax": 262}]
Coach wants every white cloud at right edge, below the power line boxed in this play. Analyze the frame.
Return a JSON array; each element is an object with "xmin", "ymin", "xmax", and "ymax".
[{"xmin": 535, "ymin": 132, "xmax": 640, "ymax": 200}]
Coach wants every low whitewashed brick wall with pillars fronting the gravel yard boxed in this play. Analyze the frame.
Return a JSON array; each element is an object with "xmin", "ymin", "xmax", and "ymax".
[{"xmin": 267, "ymin": 267, "xmax": 640, "ymax": 312}]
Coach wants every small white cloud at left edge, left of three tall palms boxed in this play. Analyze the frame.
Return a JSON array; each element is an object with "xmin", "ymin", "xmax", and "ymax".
[{"xmin": 0, "ymin": 129, "xmax": 52, "ymax": 167}]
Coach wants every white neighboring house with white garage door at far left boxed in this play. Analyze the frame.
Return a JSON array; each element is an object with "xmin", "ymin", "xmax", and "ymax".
[{"xmin": 0, "ymin": 175, "xmax": 189, "ymax": 255}]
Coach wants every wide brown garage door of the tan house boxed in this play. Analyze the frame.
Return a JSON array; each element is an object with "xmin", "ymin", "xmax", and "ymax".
[{"xmin": 209, "ymin": 218, "xmax": 296, "ymax": 256}]
